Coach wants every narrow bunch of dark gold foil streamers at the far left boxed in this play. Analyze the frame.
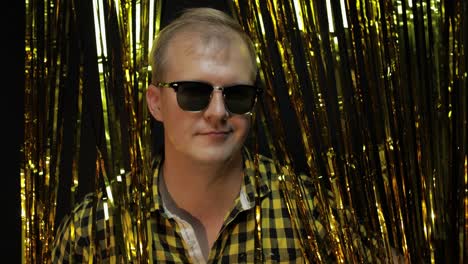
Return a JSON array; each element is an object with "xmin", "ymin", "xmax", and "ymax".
[{"xmin": 20, "ymin": 0, "xmax": 70, "ymax": 263}]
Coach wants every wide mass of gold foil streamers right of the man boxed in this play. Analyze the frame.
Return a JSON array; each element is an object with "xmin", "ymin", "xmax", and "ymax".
[{"xmin": 233, "ymin": 0, "xmax": 468, "ymax": 263}]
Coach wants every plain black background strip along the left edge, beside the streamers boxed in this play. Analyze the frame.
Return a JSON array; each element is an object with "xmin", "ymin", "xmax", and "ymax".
[{"xmin": 5, "ymin": 0, "xmax": 25, "ymax": 263}]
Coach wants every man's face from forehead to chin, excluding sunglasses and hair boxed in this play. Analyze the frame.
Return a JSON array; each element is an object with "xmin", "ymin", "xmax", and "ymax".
[{"xmin": 148, "ymin": 34, "xmax": 254, "ymax": 164}]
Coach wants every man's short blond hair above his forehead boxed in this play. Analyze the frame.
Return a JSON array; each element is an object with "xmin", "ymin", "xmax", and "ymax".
[{"xmin": 149, "ymin": 8, "xmax": 257, "ymax": 82}]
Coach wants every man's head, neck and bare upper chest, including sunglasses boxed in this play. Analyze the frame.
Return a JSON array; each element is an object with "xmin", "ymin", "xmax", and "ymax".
[{"xmin": 147, "ymin": 6, "xmax": 266, "ymax": 261}]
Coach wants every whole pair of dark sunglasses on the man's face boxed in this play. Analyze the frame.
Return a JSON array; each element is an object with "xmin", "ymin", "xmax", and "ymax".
[{"xmin": 156, "ymin": 81, "xmax": 262, "ymax": 115}]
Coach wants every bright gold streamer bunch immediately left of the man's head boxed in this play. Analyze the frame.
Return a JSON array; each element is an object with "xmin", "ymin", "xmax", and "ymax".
[{"xmin": 89, "ymin": 1, "xmax": 161, "ymax": 263}]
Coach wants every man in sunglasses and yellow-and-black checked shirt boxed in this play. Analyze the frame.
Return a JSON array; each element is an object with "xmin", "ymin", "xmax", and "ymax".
[{"xmin": 52, "ymin": 8, "xmax": 392, "ymax": 263}]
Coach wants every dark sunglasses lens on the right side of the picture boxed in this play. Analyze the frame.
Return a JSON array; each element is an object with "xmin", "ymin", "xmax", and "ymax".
[{"xmin": 224, "ymin": 85, "xmax": 256, "ymax": 115}]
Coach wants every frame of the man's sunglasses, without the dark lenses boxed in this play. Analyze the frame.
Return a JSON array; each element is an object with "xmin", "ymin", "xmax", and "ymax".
[{"xmin": 155, "ymin": 81, "xmax": 263, "ymax": 115}]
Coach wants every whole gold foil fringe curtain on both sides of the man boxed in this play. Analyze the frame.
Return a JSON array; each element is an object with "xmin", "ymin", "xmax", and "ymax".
[{"xmin": 20, "ymin": 0, "xmax": 468, "ymax": 263}]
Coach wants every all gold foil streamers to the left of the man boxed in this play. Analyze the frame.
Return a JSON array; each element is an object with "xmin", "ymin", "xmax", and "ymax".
[{"xmin": 20, "ymin": 0, "xmax": 161, "ymax": 263}]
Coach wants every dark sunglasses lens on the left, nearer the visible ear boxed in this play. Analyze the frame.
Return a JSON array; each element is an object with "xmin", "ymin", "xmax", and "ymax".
[{"xmin": 177, "ymin": 82, "xmax": 213, "ymax": 111}]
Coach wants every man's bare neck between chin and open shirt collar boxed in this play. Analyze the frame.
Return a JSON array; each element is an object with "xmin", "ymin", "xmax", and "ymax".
[{"xmin": 162, "ymin": 150, "xmax": 243, "ymax": 221}]
